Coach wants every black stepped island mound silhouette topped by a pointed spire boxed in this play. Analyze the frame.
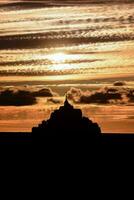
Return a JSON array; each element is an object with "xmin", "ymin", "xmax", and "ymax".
[{"xmin": 32, "ymin": 98, "xmax": 101, "ymax": 138}]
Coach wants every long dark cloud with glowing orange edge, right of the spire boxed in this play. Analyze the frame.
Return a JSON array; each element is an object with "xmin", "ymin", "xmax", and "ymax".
[{"xmin": 67, "ymin": 87, "xmax": 134, "ymax": 104}]
